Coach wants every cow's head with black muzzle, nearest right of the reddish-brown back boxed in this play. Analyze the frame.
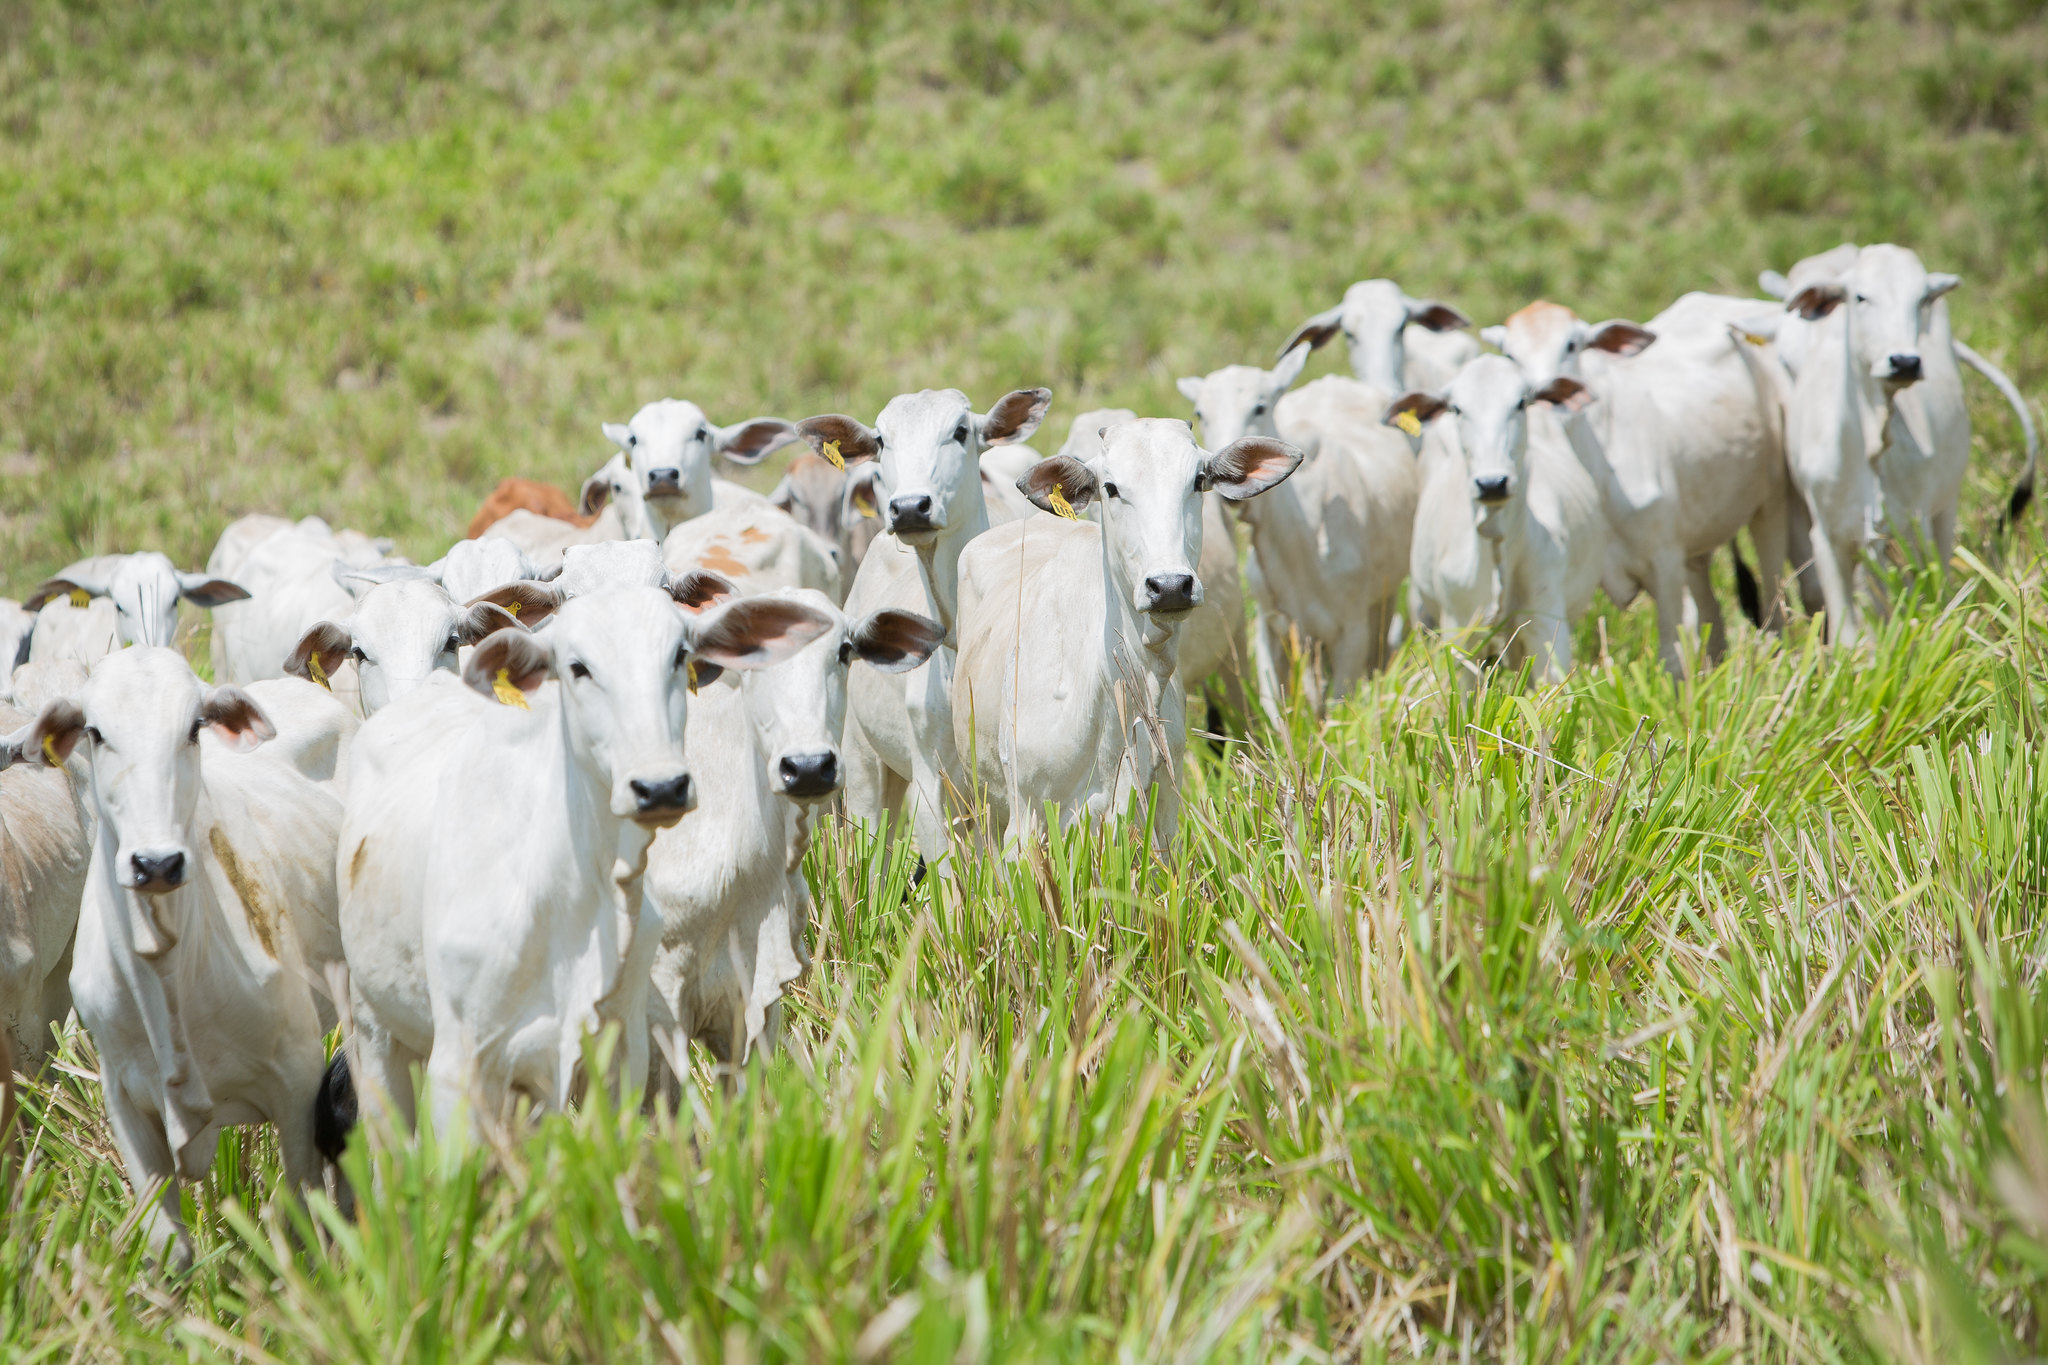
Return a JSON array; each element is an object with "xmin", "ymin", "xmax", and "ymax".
[{"xmin": 582, "ymin": 399, "xmax": 797, "ymax": 540}]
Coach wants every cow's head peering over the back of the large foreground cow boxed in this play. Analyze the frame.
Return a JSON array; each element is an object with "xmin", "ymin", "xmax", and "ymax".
[{"xmin": 285, "ymin": 565, "xmax": 532, "ymax": 716}]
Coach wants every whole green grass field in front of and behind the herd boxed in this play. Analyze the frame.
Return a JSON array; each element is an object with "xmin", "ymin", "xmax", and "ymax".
[{"xmin": 0, "ymin": 0, "xmax": 2048, "ymax": 1365}]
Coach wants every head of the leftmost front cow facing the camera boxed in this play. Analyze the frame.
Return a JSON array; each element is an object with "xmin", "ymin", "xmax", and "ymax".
[{"xmin": 6, "ymin": 645, "xmax": 276, "ymax": 958}]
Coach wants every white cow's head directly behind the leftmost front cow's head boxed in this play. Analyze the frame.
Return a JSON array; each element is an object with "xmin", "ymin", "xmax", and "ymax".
[{"xmin": 23, "ymin": 551, "xmax": 248, "ymax": 667}]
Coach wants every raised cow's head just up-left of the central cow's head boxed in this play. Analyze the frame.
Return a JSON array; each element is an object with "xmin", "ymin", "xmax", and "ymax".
[{"xmin": 797, "ymin": 389, "xmax": 1053, "ymax": 546}]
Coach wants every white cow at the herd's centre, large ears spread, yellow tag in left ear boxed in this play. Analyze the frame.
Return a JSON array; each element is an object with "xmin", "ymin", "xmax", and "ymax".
[{"xmin": 952, "ymin": 420, "xmax": 1303, "ymax": 853}]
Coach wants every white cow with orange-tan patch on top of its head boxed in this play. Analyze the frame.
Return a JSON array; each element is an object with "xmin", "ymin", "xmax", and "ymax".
[{"xmin": 1483, "ymin": 293, "xmax": 1788, "ymax": 675}]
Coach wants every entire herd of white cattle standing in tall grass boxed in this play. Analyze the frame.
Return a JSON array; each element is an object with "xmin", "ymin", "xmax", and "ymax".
[{"xmin": 0, "ymin": 246, "xmax": 2036, "ymax": 1263}]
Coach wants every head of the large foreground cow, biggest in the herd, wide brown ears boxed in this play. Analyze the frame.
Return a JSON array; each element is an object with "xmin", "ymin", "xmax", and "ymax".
[{"xmin": 463, "ymin": 573, "xmax": 831, "ymax": 827}]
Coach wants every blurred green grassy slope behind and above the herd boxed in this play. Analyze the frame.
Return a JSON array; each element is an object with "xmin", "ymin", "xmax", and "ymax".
[{"xmin": 0, "ymin": 0, "xmax": 2048, "ymax": 591}]
